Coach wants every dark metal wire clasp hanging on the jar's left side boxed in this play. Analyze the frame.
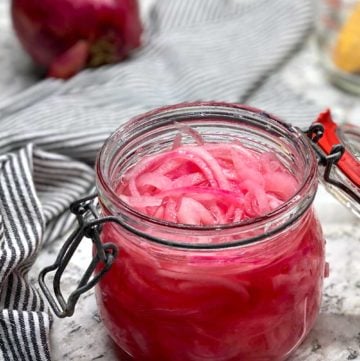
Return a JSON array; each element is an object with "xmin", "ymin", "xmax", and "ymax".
[{"xmin": 39, "ymin": 194, "xmax": 118, "ymax": 318}]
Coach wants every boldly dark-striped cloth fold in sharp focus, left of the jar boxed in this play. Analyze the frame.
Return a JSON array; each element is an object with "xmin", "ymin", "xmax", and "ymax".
[{"xmin": 0, "ymin": 144, "xmax": 94, "ymax": 361}]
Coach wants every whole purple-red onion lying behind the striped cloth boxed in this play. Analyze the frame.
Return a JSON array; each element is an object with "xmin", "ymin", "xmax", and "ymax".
[{"xmin": 11, "ymin": 0, "xmax": 142, "ymax": 79}]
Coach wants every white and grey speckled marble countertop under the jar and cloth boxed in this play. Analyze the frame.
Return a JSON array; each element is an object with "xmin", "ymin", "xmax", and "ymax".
[{"xmin": 0, "ymin": 0, "xmax": 360, "ymax": 361}]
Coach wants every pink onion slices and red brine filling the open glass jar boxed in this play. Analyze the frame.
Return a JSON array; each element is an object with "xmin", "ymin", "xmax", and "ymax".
[{"xmin": 97, "ymin": 139, "xmax": 325, "ymax": 361}]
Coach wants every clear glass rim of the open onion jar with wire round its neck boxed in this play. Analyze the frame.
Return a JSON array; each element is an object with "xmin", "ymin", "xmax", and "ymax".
[{"xmin": 95, "ymin": 101, "xmax": 317, "ymax": 250}]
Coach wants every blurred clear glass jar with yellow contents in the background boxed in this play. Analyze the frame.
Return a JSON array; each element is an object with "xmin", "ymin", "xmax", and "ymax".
[{"xmin": 316, "ymin": 0, "xmax": 360, "ymax": 94}]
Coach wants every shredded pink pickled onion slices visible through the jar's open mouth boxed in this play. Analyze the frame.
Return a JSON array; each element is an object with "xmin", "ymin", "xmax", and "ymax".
[{"xmin": 117, "ymin": 138, "xmax": 299, "ymax": 225}]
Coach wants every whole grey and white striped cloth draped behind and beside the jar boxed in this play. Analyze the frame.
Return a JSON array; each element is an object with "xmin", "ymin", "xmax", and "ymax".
[{"xmin": 0, "ymin": 0, "xmax": 317, "ymax": 361}]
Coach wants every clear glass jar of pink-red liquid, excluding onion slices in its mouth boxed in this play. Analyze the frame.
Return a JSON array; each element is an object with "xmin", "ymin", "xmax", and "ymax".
[{"xmin": 96, "ymin": 103, "xmax": 325, "ymax": 361}]
